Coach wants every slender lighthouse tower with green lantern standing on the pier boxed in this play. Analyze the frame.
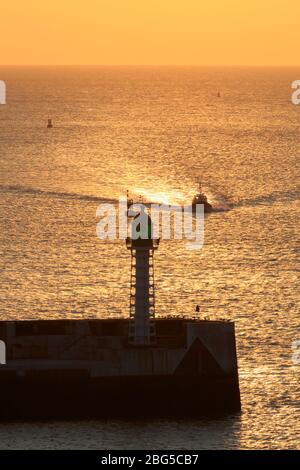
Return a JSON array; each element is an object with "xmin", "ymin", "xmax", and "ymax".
[{"xmin": 126, "ymin": 206, "xmax": 159, "ymax": 346}]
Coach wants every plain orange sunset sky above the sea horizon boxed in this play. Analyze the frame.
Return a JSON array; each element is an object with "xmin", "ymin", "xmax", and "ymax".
[{"xmin": 0, "ymin": 0, "xmax": 300, "ymax": 65}]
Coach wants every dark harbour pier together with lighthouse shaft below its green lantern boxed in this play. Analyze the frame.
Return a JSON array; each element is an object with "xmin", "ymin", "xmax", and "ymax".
[{"xmin": 0, "ymin": 208, "xmax": 241, "ymax": 420}]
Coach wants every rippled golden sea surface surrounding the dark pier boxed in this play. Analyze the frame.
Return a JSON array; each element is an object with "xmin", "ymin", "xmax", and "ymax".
[{"xmin": 0, "ymin": 67, "xmax": 300, "ymax": 449}]
